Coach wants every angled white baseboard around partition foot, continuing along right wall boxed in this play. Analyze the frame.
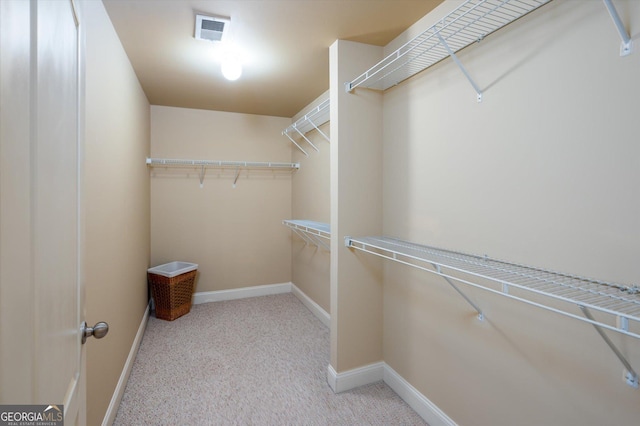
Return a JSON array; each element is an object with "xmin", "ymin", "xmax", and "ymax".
[{"xmin": 327, "ymin": 361, "xmax": 457, "ymax": 426}]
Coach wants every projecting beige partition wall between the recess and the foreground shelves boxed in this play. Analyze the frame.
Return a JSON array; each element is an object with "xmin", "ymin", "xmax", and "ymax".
[{"xmin": 329, "ymin": 40, "xmax": 382, "ymax": 373}]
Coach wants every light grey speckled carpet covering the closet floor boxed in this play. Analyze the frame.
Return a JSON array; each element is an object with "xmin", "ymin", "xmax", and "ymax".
[{"xmin": 114, "ymin": 293, "xmax": 425, "ymax": 426}]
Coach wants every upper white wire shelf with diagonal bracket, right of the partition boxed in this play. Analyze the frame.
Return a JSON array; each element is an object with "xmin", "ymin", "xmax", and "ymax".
[{"xmin": 346, "ymin": 0, "xmax": 551, "ymax": 93}]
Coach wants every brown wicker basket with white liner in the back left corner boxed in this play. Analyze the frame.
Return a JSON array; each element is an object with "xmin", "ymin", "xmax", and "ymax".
[{"xmin": 147, "ymin": 262, "xmax": 198, "ymax": 321}]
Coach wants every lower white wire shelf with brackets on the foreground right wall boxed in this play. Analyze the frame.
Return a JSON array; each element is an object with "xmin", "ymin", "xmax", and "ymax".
[{"xmin": 345, "ymin": 237, "xmax": 640, "ymax": 388}]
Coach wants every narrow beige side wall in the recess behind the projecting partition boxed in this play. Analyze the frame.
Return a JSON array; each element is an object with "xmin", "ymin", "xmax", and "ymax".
[{"xmin": 290, "ymin": 92, "xmax": 331, "ymax": 313}]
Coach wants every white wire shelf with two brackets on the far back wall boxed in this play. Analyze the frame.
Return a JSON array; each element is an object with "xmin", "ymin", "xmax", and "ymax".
[{"xmin": 146, "ymin": 157, "xmax": 300, "ymax": 187}]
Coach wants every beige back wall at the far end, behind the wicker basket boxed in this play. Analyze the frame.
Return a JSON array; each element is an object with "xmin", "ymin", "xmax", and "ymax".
[{"xmin": 151, "ymin": 106, "xmax": 291, "ymax": 292}]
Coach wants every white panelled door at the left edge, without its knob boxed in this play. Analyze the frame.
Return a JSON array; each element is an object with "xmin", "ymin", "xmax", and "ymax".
[{"xmin": 0, "ymin": 0, "xmax": 95, "ymax": 425}]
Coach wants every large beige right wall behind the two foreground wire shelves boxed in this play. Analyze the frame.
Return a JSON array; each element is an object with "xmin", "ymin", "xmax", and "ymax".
[{"xmin": 383, "ymin": 1, "xmax": 640, "ymax": 425}]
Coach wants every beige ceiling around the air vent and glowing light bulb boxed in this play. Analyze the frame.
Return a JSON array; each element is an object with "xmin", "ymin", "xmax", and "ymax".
[{"xmin": 103, "ymin": 0, "xmax": 443, "ymax": 117}]
